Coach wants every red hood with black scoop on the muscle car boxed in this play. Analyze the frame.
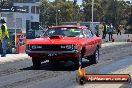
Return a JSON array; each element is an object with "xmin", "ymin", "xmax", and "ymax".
[{"xmin": 27, "ymin": 36, "xmax": 81, "ymax": 44}]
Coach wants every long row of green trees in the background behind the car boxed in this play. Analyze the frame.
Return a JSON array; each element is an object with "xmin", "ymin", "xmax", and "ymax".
[{"xmin": 40, "ymin": 0, "xmax": 131, "ymax": 29}]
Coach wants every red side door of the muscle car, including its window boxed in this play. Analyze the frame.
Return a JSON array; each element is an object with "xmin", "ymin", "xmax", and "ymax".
[{"xmin": 86, "ymin": 28, "xmax": 96, "ymax": 55}]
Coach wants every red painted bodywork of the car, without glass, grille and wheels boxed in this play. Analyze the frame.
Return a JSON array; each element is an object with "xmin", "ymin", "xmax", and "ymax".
[{"xmin": 26, "ymin": 25, "xmax": 102, "ymax": 60}]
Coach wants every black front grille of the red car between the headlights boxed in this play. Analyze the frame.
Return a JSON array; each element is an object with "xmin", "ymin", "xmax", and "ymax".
[{"xmin": 30, "ymin": 44, "xmax": 71, "ymax": 51}]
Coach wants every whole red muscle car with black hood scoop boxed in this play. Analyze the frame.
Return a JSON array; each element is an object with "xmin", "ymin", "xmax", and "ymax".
[{"xmin": 26, "ymin": 25, "xmax": 102, "ymax": 68}]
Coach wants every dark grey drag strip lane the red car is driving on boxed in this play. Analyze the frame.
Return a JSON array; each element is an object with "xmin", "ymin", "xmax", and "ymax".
[{"xmin": 0, "ymin": 44, "xmax": 132, "ymax": 88}]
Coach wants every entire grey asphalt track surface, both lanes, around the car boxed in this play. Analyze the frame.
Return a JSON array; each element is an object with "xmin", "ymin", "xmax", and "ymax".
[{"xmin": 0, "ymin": 43, "xmax": 132, "ymax": 88}]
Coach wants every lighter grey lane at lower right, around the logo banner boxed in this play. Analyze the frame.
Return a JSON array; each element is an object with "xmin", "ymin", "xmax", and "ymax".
[{"xmin": 12, "ymin": 56, "xmax": 132, "ymax": 88}]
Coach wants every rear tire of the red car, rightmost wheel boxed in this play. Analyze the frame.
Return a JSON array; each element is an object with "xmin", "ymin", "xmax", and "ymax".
[{"xmin": 88, "ymin": 48, "xmax": 99, "ymax": 64}]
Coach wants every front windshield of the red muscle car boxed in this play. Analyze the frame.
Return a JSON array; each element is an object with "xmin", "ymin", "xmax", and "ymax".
[{"xmin": 44, "ymin": 28, "xmax": 84, "ymax": 37}]
